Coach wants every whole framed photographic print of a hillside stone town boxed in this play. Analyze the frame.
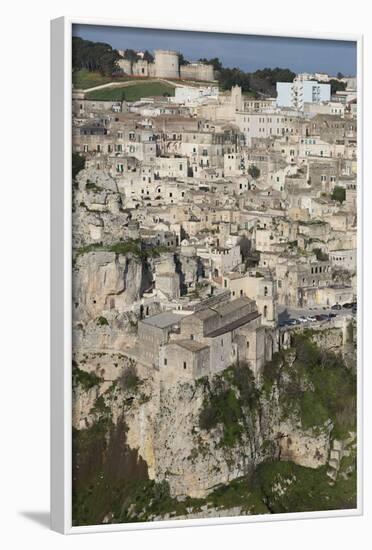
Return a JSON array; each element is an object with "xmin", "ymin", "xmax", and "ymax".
[{"xmin": 51, "ymin": 18, "xmax": 362, "ymax": 533}]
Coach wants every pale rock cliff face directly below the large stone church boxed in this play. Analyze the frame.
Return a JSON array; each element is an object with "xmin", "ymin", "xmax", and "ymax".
[{"xmin": 74, "ymin": 357, "xmax": 330, "ymax": 498}]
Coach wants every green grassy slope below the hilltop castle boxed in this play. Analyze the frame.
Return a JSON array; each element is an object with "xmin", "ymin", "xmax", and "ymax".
[{"xmin": 87, "ymin": 81, "xmax": 175, "ymax": 101}]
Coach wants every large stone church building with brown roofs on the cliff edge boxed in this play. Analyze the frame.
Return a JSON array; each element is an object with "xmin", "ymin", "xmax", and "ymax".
[{"xmin": 138, "ymin": 297, "xmax": 272, "ymax": 384}]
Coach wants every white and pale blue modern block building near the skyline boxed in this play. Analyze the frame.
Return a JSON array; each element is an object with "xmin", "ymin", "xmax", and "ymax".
[{"xmin": 276, "ymin": 79, "xmax": 331, "ymax": 111}]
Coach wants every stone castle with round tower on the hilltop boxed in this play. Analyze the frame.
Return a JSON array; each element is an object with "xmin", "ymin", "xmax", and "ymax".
[{"xmin": 119, "ymin": 50, "xmax": 214, "ymax": 81}]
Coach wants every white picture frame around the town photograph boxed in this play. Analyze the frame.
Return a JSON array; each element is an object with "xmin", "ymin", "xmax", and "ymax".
[{"xmin": 51, "ymin": 17, "xmax": 363, "ymax": 534}]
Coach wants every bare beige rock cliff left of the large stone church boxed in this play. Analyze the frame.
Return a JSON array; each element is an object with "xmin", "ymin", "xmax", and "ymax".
[{"xmin": 72, "ymin": 250, "xmax": 149, "ymax": 351}]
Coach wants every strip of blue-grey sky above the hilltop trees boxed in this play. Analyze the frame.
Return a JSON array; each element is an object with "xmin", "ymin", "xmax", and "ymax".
[{"xmin": 73, "ymin": 25, "xmax": 356, "ymax": 76}]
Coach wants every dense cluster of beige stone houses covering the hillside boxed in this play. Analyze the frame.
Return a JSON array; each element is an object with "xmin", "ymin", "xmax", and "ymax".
[{"xmin": 73, "ymin": 70, "xmax": 357, "ymax": 382}]
